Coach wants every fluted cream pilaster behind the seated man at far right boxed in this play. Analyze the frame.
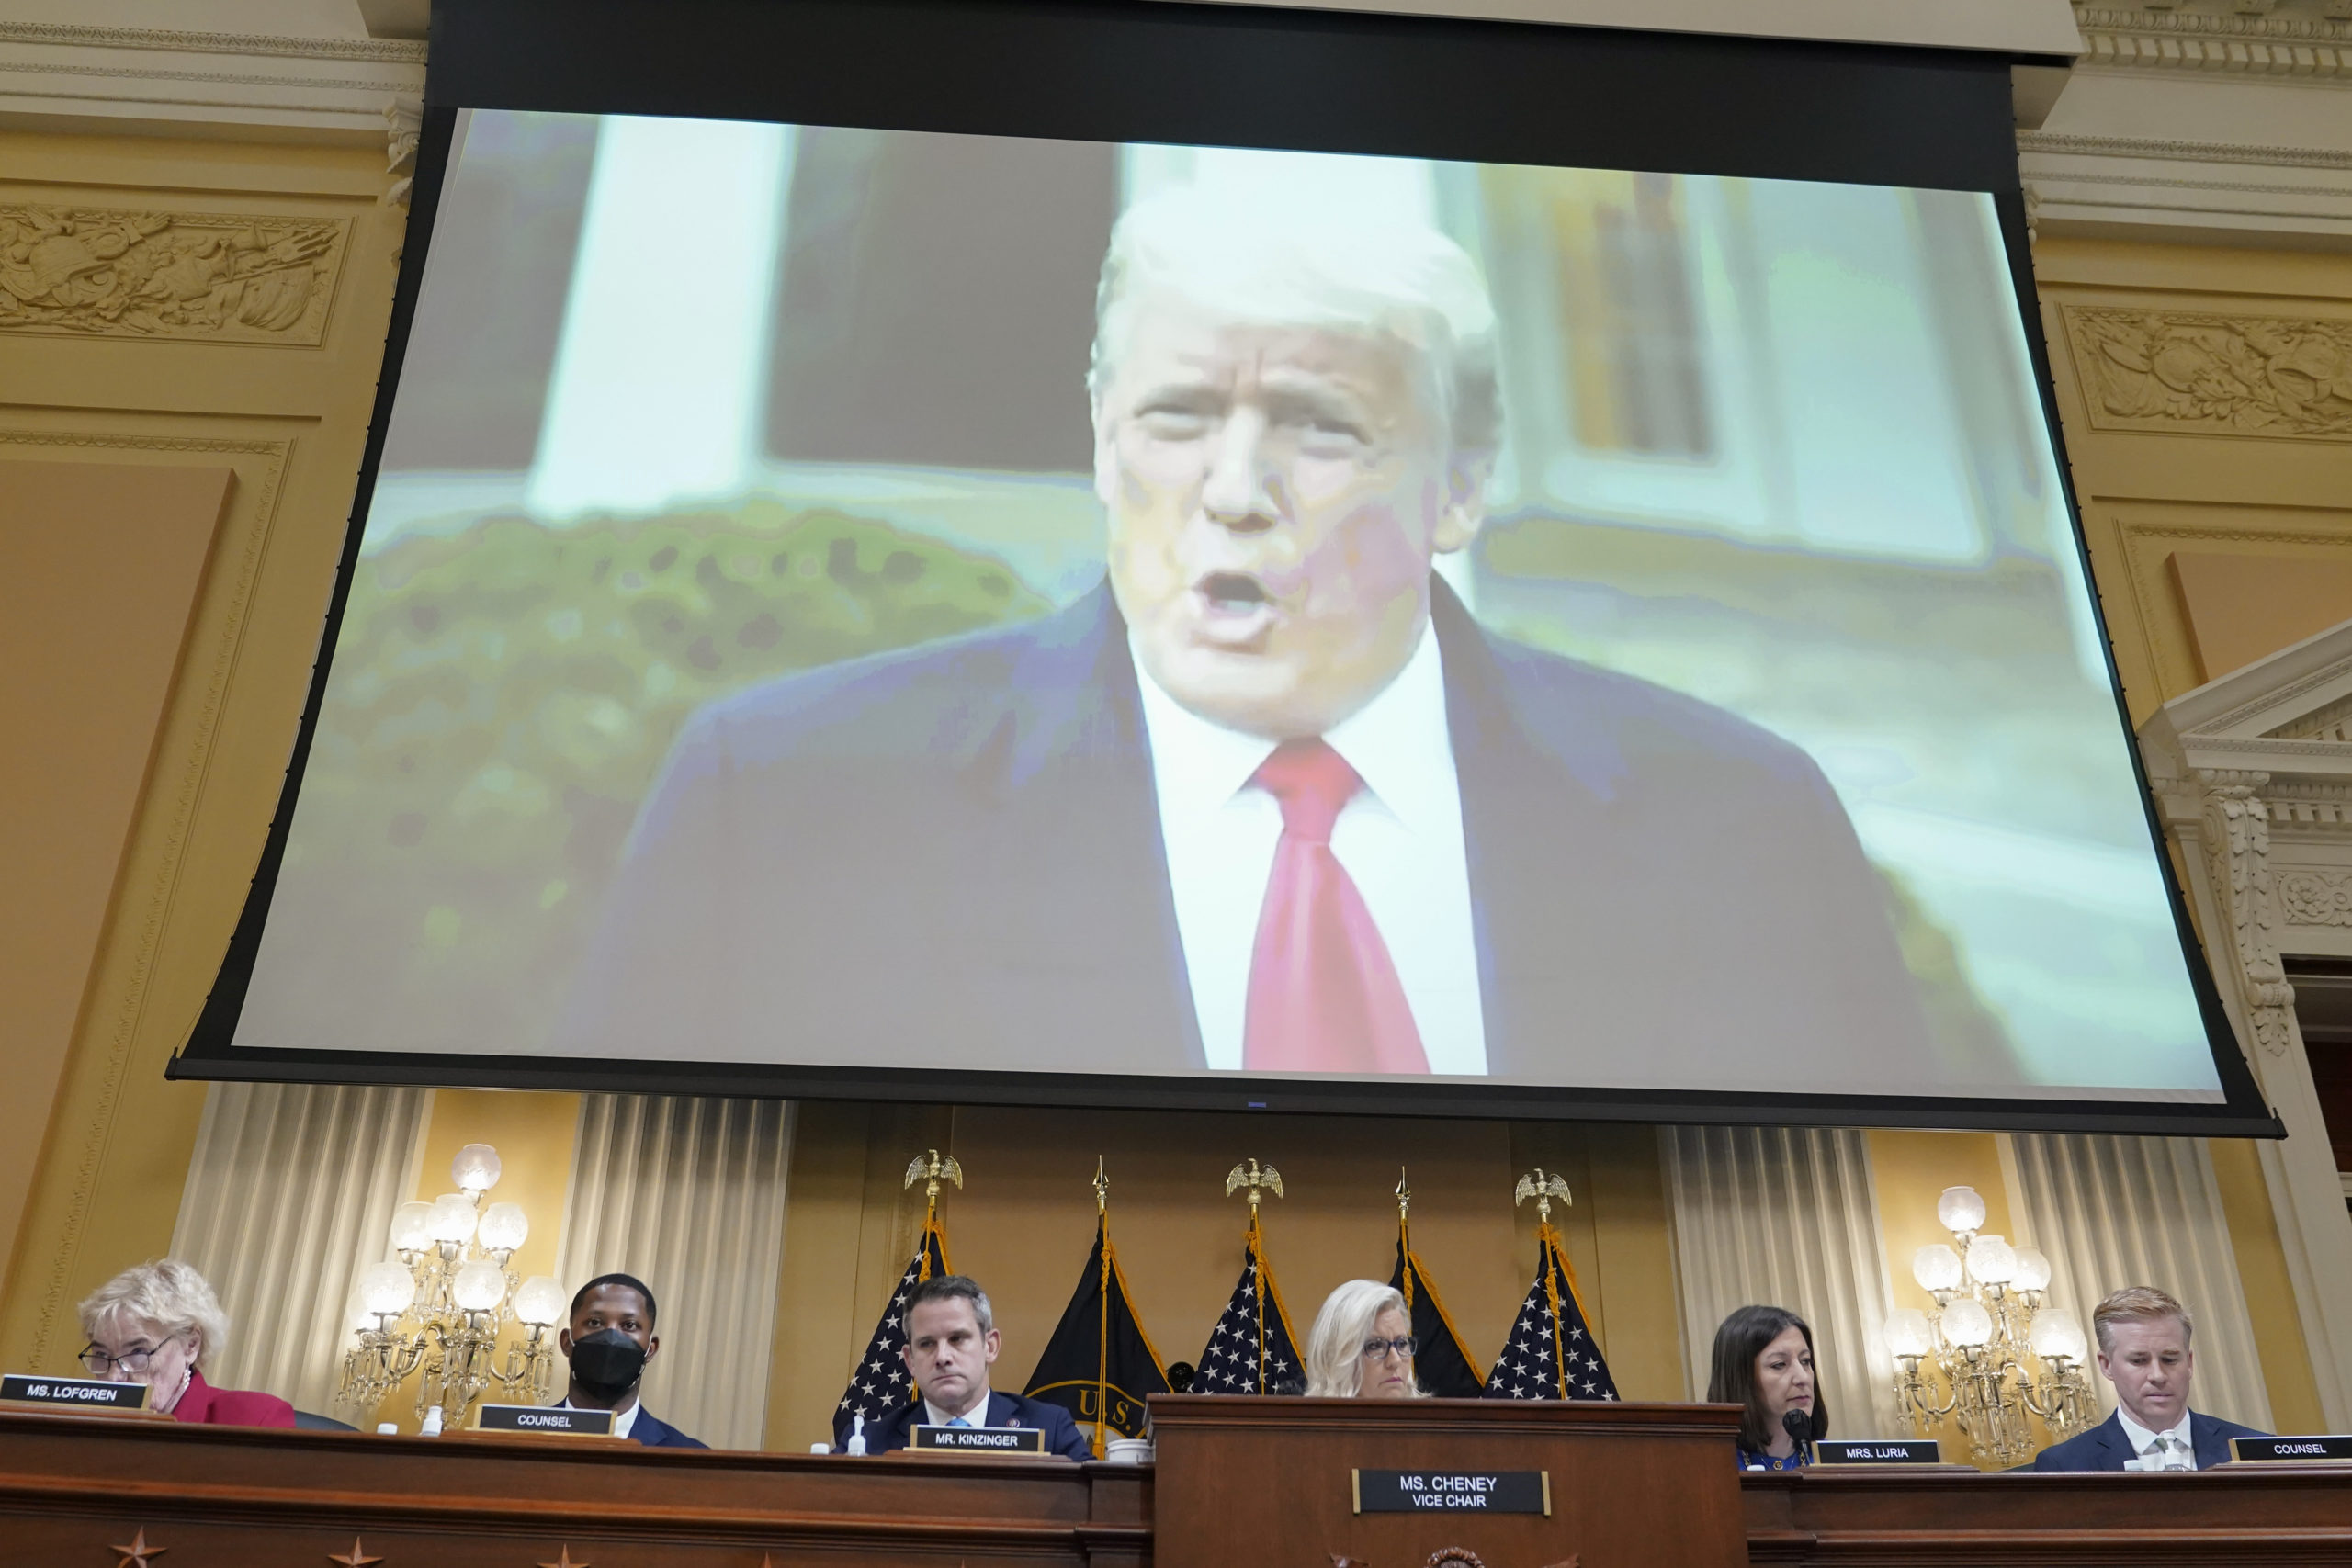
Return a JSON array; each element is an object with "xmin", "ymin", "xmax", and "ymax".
[{"xmin": 2008, "ymin": 1134, "xmax": 2269, "ymax": 1432}]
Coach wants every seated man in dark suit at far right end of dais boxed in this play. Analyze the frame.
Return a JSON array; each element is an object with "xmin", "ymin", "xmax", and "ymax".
[{"xmin": 2034, "ymin": 1286, "xmax": 2267, "ymax": 1472}]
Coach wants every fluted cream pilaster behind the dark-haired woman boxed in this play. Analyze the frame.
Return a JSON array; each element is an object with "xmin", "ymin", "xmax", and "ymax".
[{"xmin": 1660, "ymin": 1126, "xmax": 1898, "ymax": 1437}]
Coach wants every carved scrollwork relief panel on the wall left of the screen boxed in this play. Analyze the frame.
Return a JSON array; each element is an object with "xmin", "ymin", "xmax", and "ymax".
[{"xmin": 0, "ymin": 205, "xmax": 350, "ymax": 348}]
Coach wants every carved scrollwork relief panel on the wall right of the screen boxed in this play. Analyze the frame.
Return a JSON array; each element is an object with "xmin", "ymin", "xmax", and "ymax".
[{"xmin": 2063, "ymin": 306, "xmax": 2352, "ymax": 440}]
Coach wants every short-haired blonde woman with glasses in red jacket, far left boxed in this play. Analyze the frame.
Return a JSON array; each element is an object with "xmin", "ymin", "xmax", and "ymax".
[{"xmin": 83, "ymin": 1258, "xmax": 294, "ymax": 1427}]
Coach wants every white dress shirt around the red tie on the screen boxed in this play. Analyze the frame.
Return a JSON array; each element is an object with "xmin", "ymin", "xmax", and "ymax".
[{"xmin": 1136, "ymin": 627, "xmax": 1487, "ymax": 1077}]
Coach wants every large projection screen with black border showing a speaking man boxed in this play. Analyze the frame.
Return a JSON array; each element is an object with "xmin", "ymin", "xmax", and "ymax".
[{"xmin": 176, "ymin": 0, "xmax": 2267, "ymax": 1131}]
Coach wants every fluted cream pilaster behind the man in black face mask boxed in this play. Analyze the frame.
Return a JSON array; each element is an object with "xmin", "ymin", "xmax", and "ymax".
[{"xmin": 555, "ymin": 1096, "xmax": 793, "ymax": 1448}]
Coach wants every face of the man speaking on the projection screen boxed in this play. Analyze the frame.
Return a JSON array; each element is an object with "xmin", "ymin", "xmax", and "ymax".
[{"xmin": 1093, "ymin": 287, "xmax": 1484, "ymax": 739}]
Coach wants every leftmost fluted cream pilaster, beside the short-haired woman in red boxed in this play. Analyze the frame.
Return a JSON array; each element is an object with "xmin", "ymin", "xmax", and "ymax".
[{"xmin": 172, "ymin": 1084, "xmax": 433, "ymax": 1416}]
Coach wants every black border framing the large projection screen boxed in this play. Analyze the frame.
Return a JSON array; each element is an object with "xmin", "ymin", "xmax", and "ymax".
[{"xmin": 164, "ymin": 0, "xmax": 2286, "ymax": 1138}]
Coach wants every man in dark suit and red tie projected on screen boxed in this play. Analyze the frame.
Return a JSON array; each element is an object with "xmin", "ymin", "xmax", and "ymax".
[{"xmin": 550, "ymin": 195, "xmax": 1948, "ymax": 1093}]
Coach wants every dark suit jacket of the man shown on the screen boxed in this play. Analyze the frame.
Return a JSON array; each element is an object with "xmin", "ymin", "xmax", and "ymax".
[{"xmin": 553, "ymin": 583, "xmax": 1933, "ymax": 1093}]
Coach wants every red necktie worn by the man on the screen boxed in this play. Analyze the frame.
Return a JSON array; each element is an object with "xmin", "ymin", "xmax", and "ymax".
[{"xmin": 1242, "ymin": 740, "xmax": 1430, "ymax": 1072}]
